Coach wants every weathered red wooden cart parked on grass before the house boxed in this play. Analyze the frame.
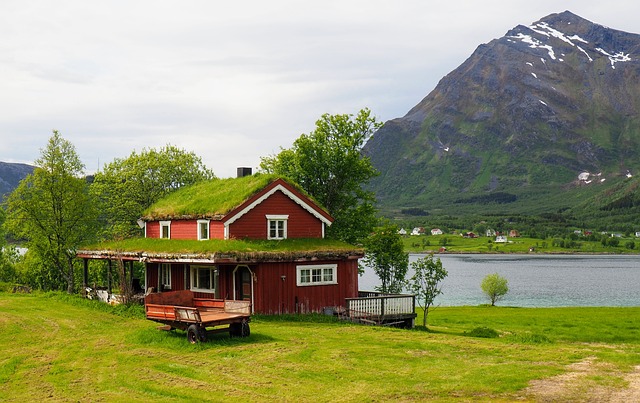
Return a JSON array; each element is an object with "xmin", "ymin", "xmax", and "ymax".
[{"xmin": 144, "ymin": 290, "xmax": 251, "ymax": 343}]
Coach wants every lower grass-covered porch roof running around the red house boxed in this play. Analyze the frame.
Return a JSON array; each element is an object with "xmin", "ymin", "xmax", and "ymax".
[{"xmin": 76, "ymin": 238, "xmax": 364, "ymax": 264}]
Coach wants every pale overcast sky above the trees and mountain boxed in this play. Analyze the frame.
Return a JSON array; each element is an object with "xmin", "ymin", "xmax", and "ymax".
[{"xmin": 0, "ymin": 0, "xmax": 640, "ymax": 177}]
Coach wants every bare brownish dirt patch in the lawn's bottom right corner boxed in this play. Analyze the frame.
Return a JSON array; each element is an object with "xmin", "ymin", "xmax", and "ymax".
[{"xmin": 525, "ymin": 357, "xmax": 640, "ymax": 403}]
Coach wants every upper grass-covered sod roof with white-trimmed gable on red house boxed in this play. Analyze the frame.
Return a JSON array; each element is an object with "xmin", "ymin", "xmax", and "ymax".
[{"xmin": 143, "ymin": 174, "xmax": 318, "ymax": 220}]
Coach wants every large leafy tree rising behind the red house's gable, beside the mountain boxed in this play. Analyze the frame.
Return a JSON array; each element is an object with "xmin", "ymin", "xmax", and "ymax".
[{"xmin": 260, "ymin": 108, "xmax": 382, "ymax": 243}]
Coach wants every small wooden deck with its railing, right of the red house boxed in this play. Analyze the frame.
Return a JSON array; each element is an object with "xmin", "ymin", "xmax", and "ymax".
[{"xmin": 340, "ymin": 291, "xmax": 418, "ymax": 329}]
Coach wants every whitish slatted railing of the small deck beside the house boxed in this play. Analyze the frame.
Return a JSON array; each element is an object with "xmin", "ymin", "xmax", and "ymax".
[{"xmin": 346, "ymin": 291, "xmax": 416, "ymax": 318}]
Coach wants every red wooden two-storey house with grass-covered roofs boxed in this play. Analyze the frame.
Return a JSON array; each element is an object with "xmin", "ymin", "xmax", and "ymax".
[{"xmin": 78, "ymin": 175, "xmax": 363, "ymax": 314}]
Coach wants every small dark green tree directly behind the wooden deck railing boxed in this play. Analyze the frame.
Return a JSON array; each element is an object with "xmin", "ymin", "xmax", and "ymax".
[{"xmin": 363, "ymin": 223, "xmax": 409, "ymax": 294}]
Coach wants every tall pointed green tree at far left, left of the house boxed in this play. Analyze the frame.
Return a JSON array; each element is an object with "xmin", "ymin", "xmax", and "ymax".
[{"xmin": 6, "ymin": 130, "xmax": 96, "ymax": 293}]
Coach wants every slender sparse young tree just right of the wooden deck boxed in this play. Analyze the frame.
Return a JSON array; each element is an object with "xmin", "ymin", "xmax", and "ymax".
[{"xmin": 408, "ymin": 254, "xmax": 449, "ymax": 327}]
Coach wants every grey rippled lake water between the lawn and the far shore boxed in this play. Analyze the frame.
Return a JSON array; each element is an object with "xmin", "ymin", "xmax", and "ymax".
[{"xmin": 358, "ymin": 252, "xmax": 640, "ymax": 307}]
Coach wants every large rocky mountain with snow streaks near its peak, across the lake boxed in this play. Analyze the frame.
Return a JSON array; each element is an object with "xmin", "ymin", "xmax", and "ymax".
[{"xmin": 363, "ymin": 11, "xmax": 640, "ymax": 213}]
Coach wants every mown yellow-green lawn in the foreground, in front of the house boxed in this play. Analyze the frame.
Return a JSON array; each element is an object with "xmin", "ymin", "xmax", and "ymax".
[{"xmin": 0, "ymin": 293, "xmax": 640, "ymax": 402}]
